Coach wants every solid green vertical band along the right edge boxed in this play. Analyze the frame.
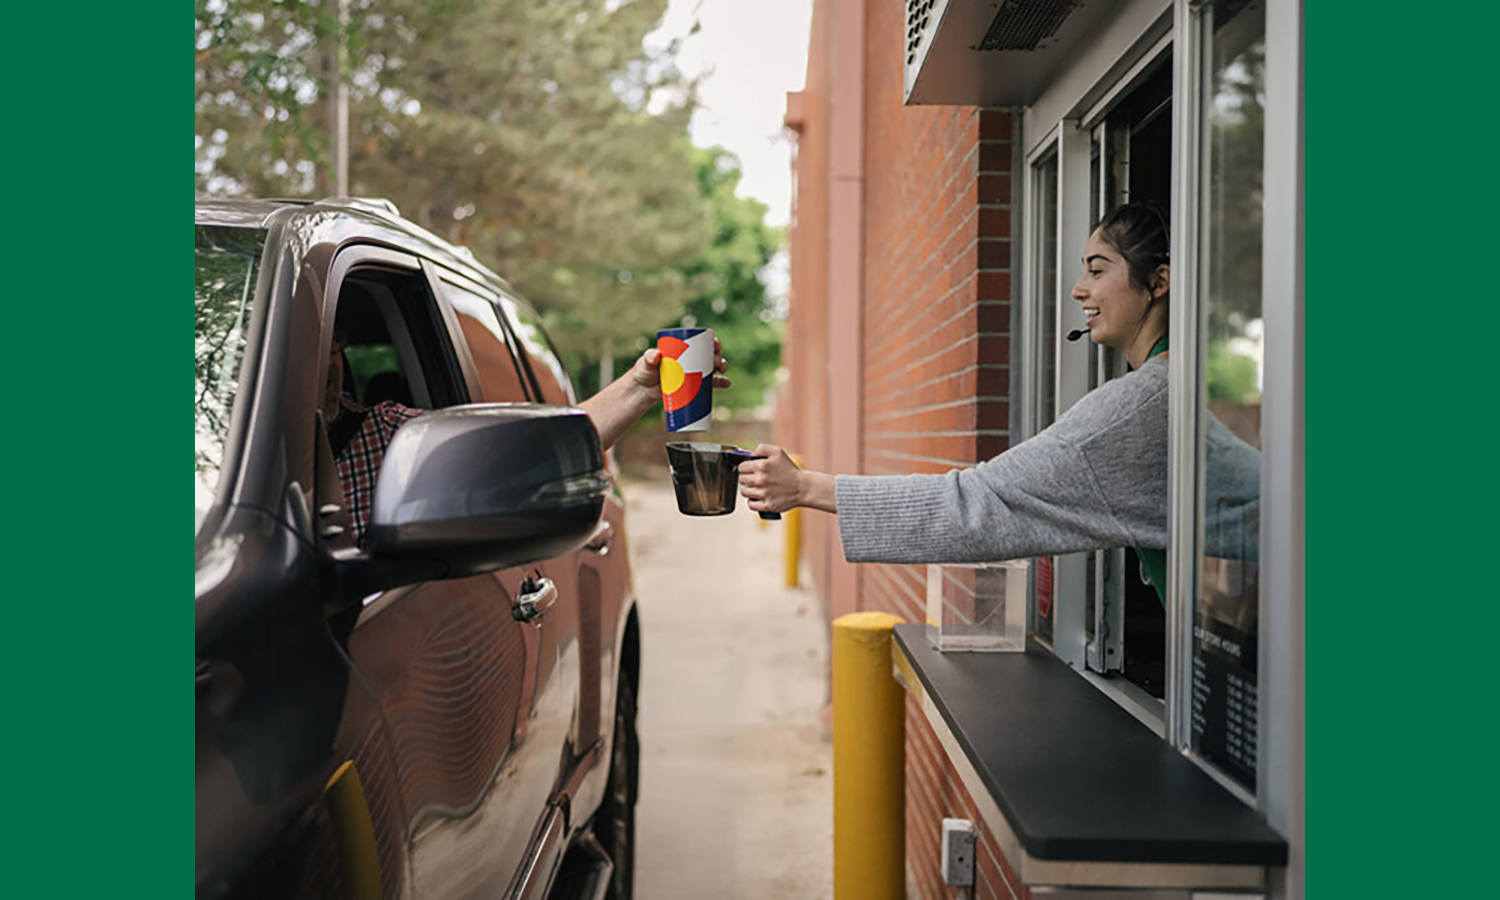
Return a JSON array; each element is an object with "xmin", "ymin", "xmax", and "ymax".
[{"xmin": 1307, "ymin": 2, "xmax": 1500, "ymax": 897}]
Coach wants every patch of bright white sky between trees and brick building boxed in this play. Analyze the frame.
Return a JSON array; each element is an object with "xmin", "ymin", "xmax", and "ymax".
[{"xmin": 647, "ymin": 0, "xmax": 813, "ymax": 225}]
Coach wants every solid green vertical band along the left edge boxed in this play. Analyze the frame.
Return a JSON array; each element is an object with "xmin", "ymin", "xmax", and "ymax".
[{"xmin": 12, "ymin": 5, "xmax": 177, "ymax": 897}]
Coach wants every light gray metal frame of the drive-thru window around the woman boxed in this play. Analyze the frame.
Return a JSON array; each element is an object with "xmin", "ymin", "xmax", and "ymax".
[{"xmin": 1019, "ymin": 0, "xmax": 1305, "ymax": 833}]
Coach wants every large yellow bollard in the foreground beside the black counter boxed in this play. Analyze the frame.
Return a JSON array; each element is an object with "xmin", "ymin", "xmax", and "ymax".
[{"xmin": 833, "ymin": 612, "xmax": 906, "ymax": 900}]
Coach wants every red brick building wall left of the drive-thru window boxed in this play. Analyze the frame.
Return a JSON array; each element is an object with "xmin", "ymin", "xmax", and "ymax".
[{"xmin": 774, "ymin": 0, "xmax": 1023, "ymax": 899}]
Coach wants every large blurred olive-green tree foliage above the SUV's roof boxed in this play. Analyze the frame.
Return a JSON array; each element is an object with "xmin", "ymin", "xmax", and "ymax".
[{"xmin": 195, "ymin": 0, "xmax": 713, "ymax": 369}]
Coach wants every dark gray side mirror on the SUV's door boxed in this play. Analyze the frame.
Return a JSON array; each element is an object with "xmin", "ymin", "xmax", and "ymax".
[{"xmin": 360, "ymin": 404, "xmax": 611, "ymax": 578}]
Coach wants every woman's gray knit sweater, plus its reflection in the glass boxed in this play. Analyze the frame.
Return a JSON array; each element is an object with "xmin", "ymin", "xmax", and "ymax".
[{"xmin": 836, "ymin": 357, "xmax": 1260, "ymax": 563}]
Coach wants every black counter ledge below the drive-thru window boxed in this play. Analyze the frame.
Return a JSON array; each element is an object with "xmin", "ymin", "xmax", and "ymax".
[{"xmin": 893, "ymin": 624, "xmax": 1287, "ymax": 881}]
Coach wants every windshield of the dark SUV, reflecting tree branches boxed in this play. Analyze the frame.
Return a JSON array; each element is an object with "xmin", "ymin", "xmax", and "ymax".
[{"xmin": 194, "ymin": 225, "xmax": 266, "ymax": 533}]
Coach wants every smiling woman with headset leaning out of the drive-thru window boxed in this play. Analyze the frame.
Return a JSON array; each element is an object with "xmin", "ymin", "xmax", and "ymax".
[{"xmin": 740, "ymin": 204, "xmax": 1172, "ymax": 593}]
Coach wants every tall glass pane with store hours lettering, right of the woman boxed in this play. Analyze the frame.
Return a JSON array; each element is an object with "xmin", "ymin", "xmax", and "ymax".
[{"xmin": 1193, "ymin": 0, "xmax": 1266, "ymax": 791}]
